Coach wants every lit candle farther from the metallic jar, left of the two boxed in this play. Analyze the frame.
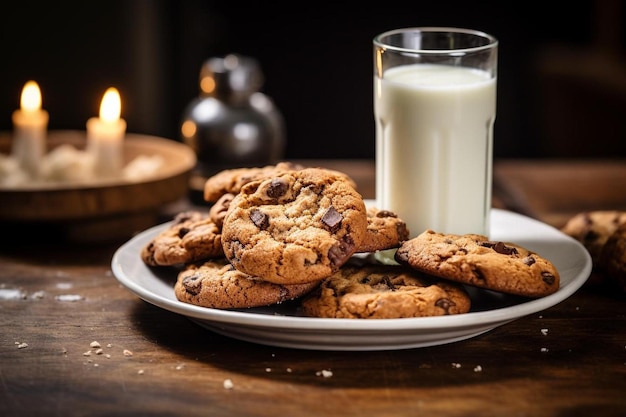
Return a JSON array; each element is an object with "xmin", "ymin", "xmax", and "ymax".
[{"xmin": 11, "ymin": 81, "xmax": 48, "ymax": 178}]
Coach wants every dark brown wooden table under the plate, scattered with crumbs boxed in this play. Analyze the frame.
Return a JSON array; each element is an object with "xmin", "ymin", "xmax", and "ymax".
[{"xmin": 0, "ymin": 160, "xmax": 626, "ymax": 417}]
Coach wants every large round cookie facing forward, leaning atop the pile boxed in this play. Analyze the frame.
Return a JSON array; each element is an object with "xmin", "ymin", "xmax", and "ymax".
[{"xmin": 222, "ymin": 168, "xmax": 367, "ymax": 284}]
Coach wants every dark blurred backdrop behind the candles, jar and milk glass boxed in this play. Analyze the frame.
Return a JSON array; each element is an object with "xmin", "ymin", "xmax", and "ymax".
[{"xmin": 0, "ymin": 0, "xmax": 626, "ymax": 158}]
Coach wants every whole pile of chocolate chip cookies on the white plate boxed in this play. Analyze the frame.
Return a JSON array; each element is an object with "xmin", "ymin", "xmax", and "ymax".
[{"xmin": 141, "ymin": 162, "xmax": 559, "ymax": 318}]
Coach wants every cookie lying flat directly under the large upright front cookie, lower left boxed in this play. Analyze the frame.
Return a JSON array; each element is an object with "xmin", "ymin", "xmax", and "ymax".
[{"xmin": 174, "ymin": 258, "xmax": 319, "ymax": 309}]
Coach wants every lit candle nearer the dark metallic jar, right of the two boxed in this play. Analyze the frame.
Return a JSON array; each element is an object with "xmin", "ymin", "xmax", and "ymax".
[{"xmin": 87, "ymin": 87, "xmax": 126, "ymax": 178}]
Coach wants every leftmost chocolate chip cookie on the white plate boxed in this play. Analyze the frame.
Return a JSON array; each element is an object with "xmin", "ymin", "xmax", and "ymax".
[{"xmin": 141, "ymin": 210, "xmax": 224, "ymax": 266}]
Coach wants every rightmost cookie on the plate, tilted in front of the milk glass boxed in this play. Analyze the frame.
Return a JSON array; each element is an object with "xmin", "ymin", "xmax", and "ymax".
[{"xmin": 395, "ymin": 230, "xmax": 560, "ymax": 298}]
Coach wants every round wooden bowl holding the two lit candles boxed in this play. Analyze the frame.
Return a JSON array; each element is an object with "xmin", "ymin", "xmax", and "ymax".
[{"xmin": 0, "ymin": 130, "xmax": 196, "ymax": 229}]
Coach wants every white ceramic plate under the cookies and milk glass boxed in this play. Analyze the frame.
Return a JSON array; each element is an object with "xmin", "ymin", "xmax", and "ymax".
[{"xmin": 112, "ymin": 209, "xmax": 592, "ymax": 351}]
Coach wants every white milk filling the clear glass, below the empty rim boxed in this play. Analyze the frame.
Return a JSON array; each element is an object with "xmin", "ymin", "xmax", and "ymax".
[{"xmin": 374, "ymin": 64, "xmax": 496, "ymax": 237}]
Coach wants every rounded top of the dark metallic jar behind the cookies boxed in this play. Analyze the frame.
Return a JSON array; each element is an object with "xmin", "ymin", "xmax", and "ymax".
[{"xmin": 200, "ymin": 54, "xmax": 264, "ymax": 100}]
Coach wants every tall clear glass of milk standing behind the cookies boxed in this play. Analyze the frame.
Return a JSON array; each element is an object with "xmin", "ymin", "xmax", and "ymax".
[{"xmin": 373, "ymin": 27, "xmax": 498, "ymax": 237}]
